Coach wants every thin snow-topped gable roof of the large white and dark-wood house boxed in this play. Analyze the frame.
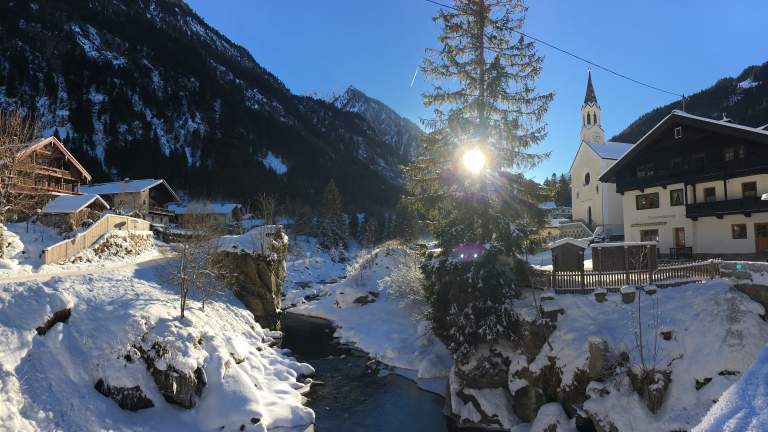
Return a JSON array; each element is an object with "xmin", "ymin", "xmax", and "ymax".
[{"xmin": 600, "ymin": 110, "xmax": 768, "ymax": 183}]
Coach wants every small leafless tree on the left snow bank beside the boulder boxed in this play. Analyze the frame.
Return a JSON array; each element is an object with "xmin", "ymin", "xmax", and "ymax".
[{"xmin": 167, "ymin": 221, "xmax": 232, "ymax": 318}]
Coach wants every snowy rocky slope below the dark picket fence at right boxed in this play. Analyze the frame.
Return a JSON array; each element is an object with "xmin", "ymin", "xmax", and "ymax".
[{"xmin": 520, "ymin": 279, "xmax": 768, "ymax": 431}]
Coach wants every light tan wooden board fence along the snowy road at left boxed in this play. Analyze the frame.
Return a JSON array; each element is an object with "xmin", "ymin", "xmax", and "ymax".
[{"xmin": 42, "ymin": 214, "xmax": 150, "ymax": 264}]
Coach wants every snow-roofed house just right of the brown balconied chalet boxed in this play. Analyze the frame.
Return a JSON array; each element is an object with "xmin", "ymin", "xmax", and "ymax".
[{"xmin": 81, "ymin": 179, "xmax": 179, "ymax": 225}]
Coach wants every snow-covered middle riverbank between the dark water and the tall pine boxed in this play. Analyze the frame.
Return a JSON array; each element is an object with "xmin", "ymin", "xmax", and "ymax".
[{"xmin": 286, "ymin": 241, "xmax": 453, "ymax": 389}]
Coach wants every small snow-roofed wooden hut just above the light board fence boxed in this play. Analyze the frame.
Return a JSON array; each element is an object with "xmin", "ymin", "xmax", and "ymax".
[{"xmin": 38, "ymin": 194, "xmax": 109, "ymax": 231}]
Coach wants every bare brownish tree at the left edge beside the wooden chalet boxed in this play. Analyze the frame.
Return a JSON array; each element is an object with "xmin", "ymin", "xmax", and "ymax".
[{"xmin": 0, "ymin": 111, "xmax": 40, "ymax": 258}]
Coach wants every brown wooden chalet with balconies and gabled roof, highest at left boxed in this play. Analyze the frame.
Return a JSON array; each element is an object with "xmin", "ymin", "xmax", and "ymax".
[{"xmin": 12, "ymin": 136, "xmax": 91, "ymax": 194}]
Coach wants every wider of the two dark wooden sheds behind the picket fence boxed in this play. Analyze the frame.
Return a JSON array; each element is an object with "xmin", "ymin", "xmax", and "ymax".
[{"xmin": 592, "ymin": 242, "xmax": 658, "ymax": 272}]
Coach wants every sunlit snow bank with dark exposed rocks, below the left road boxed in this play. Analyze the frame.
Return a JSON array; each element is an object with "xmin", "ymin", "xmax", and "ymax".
[{"xmin": 0, "ymin": 264, "xmax": 314, "ymax": 431}]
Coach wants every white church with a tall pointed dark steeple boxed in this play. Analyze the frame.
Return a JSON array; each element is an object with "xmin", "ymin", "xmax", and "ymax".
[{"xmin": 570, "ymin": 72, "xmax": 632, "ymax": 240}]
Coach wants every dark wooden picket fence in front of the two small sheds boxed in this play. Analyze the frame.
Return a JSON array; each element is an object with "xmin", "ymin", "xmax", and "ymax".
[{"xmin": 532, "ymin": 260, "xmax": 720, "ymax": 292}]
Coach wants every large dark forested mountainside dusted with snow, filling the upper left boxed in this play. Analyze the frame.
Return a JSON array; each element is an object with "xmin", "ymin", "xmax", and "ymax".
[{"xmin": 0, "ymin": 0, "xmax": 404, "ymax": 208}]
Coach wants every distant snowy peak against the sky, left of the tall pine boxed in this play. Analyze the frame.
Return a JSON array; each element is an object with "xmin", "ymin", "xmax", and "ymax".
[{"xmin": 328, "ymin": 86, "xmax": 421, "ymax": 159}]
